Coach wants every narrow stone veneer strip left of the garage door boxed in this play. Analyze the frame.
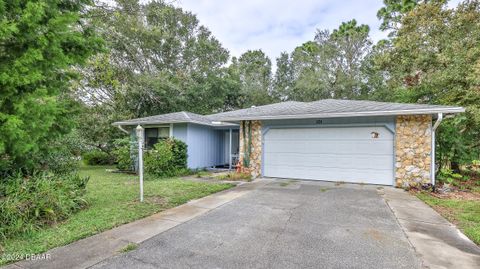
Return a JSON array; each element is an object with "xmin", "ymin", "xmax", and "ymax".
[{"xmin": 239, "ymin": 120, "xmax": 262, "ymax": 178}]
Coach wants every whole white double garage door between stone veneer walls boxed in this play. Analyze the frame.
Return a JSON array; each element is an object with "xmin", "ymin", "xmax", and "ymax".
[{"xmin": 263, "ymin": 127, "xmax": 393, "ymax": 185}]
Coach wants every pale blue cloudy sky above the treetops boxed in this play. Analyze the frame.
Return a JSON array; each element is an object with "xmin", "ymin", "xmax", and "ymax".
[{"xmin": 173, "ymin": 0, "xmax": 459, "ymax": 63}]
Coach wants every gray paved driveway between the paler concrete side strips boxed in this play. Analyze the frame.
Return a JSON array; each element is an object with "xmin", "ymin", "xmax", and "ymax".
[{"xmin": 95, "ymin": 180, "xmax": 421, "ymax": 268}]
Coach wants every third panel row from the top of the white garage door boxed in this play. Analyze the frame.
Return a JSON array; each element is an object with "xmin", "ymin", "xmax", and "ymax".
[{"xmin": 268, "ymin": 153, "xmax": 393, "ymax": 169}]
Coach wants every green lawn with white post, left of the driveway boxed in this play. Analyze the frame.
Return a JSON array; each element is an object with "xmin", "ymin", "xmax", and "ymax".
[{"xmin": 0, "ymin": 166, "xmax": 233, "ymax": 264}]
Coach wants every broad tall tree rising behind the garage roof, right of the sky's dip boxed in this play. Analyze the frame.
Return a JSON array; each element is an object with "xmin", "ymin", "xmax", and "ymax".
[{"xmin": 275, "ymin": 20, "xmax": 373, "ymax": 101}]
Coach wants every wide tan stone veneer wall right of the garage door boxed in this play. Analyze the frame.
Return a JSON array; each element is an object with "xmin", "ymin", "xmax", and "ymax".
[{"xmin": 395, "ymin": 115, "xmax": 432, "ymax": 188}]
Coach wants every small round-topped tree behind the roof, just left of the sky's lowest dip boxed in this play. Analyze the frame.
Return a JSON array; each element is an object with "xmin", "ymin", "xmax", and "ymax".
[{"xmin": 237, "ymin": 50, "xmax": 272, "ymax": 107}]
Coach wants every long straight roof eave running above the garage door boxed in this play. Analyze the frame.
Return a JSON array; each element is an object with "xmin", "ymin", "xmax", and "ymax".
[{"xmin": 210, "ymin": 107, "xmax": 465, "ymax": 122}]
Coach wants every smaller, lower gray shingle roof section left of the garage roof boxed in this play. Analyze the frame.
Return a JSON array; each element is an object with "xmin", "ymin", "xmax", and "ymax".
[{"xmin": 113, "ymin": 111, "xmax": 232, "ymax": 126}]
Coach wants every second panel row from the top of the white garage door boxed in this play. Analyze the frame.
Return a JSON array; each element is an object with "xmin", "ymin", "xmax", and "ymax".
[{"xmin": 264, "ymin": 140, "xmax": 393, "ymax": 155}]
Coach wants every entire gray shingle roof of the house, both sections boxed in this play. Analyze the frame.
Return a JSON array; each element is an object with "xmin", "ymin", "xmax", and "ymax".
[{"xmin": 113, "ymin": 99, "xmax": 465, "ymax": 126}]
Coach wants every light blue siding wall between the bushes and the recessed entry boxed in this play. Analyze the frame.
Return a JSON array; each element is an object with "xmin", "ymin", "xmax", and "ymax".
[{"xmin": 187, "ymin": 123, "xmax": 223, "ymax": 169}]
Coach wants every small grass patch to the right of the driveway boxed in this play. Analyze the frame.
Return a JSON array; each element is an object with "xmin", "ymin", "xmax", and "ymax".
[{"xmin": 417, "ymin": 192, "xmax": 480, "ymax": 245}]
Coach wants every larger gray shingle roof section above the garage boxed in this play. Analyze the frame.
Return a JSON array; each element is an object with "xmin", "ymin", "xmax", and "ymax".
[{"xmin": 209, "ymin": 99, "xmax": 465, "ymax": 121}]
